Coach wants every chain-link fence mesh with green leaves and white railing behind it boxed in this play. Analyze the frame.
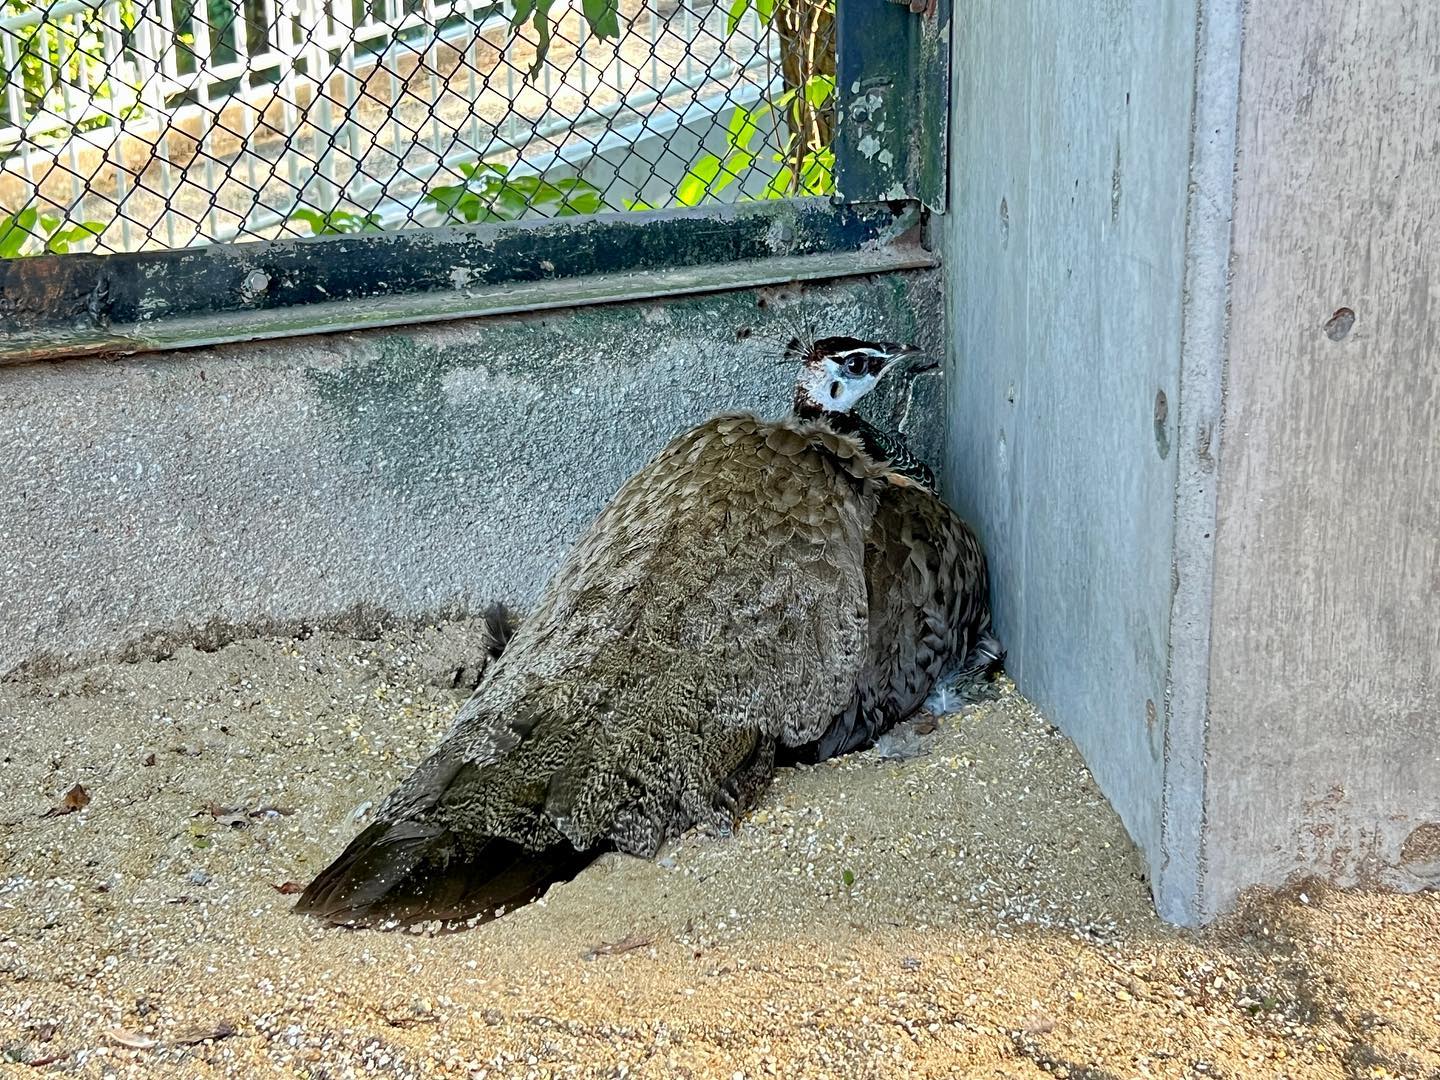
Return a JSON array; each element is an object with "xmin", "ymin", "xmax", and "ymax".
[{"xmin": 0, "ymin": 0, "xmax": 835, "ymax": 258}]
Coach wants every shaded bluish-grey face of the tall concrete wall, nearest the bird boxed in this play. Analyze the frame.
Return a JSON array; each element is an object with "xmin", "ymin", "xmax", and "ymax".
[{"xmin": 943, "ymin": 0, "xmax": 1195, "ymax": 915}]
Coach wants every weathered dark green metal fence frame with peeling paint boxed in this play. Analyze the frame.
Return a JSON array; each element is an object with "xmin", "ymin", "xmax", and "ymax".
[{"xmin": 0, "ymin": 0, "xmax": 949, "ymax": 364}]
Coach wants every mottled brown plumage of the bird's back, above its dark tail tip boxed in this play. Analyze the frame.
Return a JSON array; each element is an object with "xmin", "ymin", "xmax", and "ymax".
[{"xmin": 348, "ymin": 415, "xmax": 880, "ymax": 869}]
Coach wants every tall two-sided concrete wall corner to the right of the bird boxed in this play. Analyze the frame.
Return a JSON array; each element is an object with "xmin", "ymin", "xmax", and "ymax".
[{"xmin": 942, "ymin": 0, "xmax": 1440, "ymax": 922}]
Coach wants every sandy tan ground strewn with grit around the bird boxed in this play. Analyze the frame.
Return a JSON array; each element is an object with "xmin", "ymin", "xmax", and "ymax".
[{"xmin": 0, "ymin": 625, "xmax": 1440, "ymax": 1080}]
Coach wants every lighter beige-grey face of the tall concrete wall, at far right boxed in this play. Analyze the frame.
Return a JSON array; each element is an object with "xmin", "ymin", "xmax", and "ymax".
[{"xmin": 1205, "ymin": 0, "xmax": 1440, "ymax": 899}]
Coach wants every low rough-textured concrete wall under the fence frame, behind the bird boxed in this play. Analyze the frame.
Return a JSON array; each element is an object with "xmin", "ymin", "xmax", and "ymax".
[{"xmin": 0, "ymin": 272, "xmax": 945, "ymax": 675}]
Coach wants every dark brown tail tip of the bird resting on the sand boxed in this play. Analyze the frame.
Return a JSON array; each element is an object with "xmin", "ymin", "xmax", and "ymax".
[{"xmin": 295, "ymin": 821, "xmax": 599, "ymax": 926}]
